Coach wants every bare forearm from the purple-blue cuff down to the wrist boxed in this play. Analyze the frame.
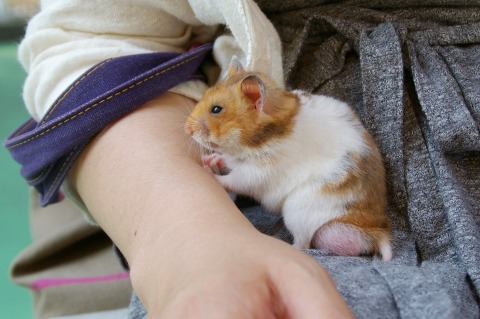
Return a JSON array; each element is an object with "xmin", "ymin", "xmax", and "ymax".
[{"xmin": 71, "ymin": 94, "xmax": 255, "ymax": 308}]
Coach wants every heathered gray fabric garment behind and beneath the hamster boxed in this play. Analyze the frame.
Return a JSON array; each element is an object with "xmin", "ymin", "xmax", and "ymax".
[{"xmin": 131, "ymin": 0, "xmax": 480, "ymax": 319}]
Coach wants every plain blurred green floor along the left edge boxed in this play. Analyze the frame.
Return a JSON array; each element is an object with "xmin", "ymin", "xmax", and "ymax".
[{"xmin": 0, "ymin": 41, "xmax": 32, "ymax": 319}]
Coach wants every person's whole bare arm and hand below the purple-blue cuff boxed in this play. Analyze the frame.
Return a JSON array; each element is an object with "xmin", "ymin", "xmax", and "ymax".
[{"xmin": 71, "ymin": 93, "xmax": 353, "ymax": 319}]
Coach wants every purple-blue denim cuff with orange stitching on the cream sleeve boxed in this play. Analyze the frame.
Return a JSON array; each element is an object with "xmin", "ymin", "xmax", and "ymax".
[{"xmin": 4, "ymin": 44, "xmax": 212, "ymax": 206}]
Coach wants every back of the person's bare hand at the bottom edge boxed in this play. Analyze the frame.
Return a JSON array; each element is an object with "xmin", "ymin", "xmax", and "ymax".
[{"xmin": 133, "ymin": 231, "xmax": 353, "ymax": 319}]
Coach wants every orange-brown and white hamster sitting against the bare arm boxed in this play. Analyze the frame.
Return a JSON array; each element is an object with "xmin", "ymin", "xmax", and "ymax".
[{"xmin": 185, "ymin": 58, "xmax": 392, "ymax": 261}]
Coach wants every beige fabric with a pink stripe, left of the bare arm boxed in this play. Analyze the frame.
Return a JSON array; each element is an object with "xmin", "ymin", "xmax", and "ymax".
[{"xmin": 11, "ymin": 190, "xmax": 132, "ymax": 319}]
